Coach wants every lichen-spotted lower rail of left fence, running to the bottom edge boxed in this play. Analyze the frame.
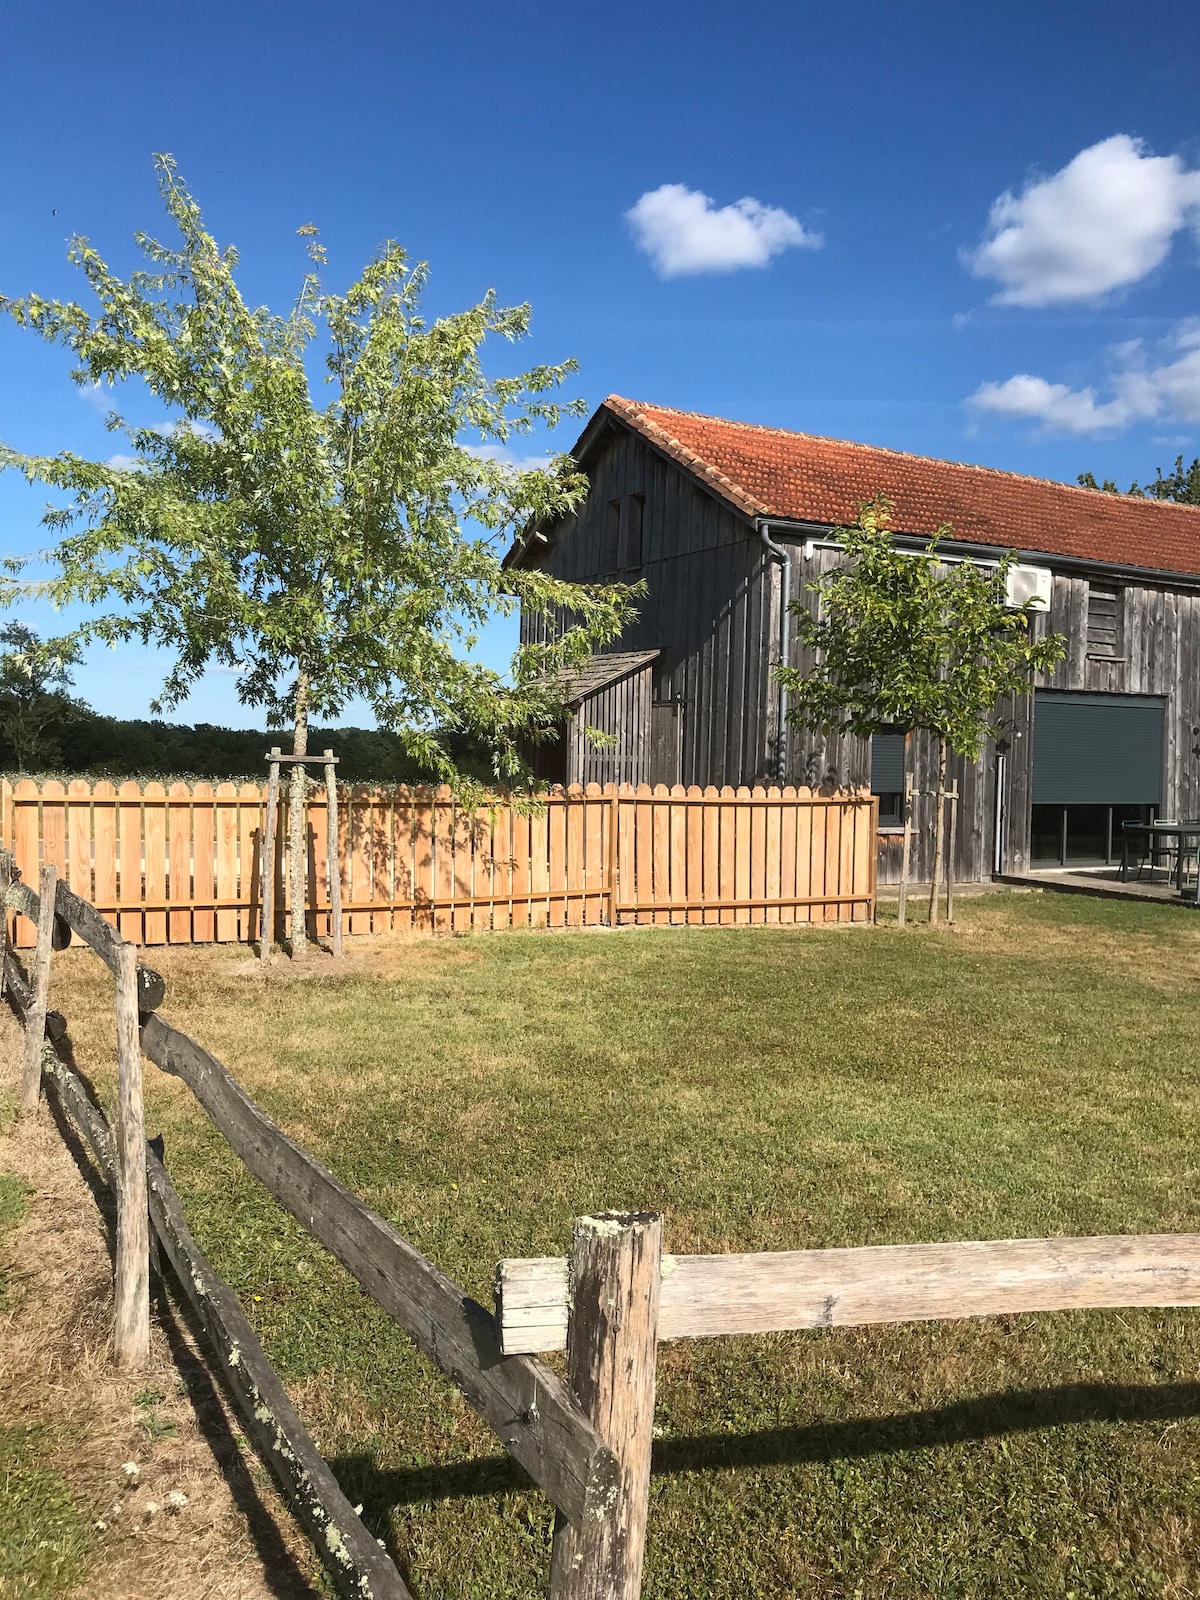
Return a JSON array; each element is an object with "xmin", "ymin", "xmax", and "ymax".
[{"xmin": 37, "ymin": 1045, "xmax": 411, "ymax": 1600}]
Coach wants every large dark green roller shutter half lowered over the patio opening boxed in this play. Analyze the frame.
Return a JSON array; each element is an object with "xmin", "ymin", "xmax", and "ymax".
[{"xmin": 1034, "ymin": 690, "xmax": 1163, "ymax": 805}]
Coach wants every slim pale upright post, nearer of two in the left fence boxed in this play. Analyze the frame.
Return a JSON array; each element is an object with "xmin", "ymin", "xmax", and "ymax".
[{"xmin": 112, "ymin": 944, "xmax": 150, "ymax": 1366}]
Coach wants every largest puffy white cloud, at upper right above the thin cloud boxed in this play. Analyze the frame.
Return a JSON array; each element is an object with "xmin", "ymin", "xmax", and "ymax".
[{"xmin": 963, "ymin": 133, "xmax": 1200, "ymax": 306}]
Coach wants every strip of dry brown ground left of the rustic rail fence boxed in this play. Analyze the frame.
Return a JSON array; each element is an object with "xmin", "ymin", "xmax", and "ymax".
[{"xmin": 0, "ymin": 1008, "xmax": 320, "ymax": 1600}]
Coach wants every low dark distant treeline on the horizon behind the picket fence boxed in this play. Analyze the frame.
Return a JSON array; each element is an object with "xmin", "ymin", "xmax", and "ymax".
[{"xmin": 0, "ymin": 707, "xmax": 486, "ymax": 784}]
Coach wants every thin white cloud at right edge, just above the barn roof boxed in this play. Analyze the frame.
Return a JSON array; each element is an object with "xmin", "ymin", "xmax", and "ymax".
[{"xmin": 970, "ymin": 320, "xmax": 1200, "ymax": 434}]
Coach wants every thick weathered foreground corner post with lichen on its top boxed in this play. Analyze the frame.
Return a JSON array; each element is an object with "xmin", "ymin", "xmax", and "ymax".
[{"xmin": 550, "ymin": 1211, "xmax": 662, "ymax": 1600}]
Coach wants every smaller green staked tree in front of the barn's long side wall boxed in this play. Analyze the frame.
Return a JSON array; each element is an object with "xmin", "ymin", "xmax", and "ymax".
[{"xmin": 776, "ymin": 494, "xmax": 1066, "ymax": 923}]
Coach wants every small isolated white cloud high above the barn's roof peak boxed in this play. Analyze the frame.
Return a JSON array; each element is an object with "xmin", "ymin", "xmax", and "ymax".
[{"xmin": 626, "ymin": 184, "xmax": 824, "ymax": 278}]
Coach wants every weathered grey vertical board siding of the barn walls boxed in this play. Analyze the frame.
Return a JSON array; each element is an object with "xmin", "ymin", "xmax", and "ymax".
[{"xmin": 522, "ymin": 427, "xmax": 1200, "ymax": 883}]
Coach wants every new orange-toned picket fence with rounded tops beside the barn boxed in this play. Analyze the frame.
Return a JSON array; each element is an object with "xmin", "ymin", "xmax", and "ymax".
[{"xmin": 0, "ymin": 779, "xmax": 878, "ymax": 946}]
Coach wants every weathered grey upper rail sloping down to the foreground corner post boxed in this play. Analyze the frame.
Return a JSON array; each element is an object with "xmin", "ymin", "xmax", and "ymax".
[{"xmin": 142, "ymin": 1016, "xmax": 618, "ymax": 1523}]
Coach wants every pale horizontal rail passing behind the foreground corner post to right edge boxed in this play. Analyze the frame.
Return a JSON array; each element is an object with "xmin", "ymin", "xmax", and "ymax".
[{"xmin": 496, "ymin": 1234, "xmax": 1200, "ymax": 1354}]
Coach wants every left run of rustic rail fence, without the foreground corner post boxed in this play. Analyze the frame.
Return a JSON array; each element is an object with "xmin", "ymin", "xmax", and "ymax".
[{"xmin": 0, "ymin": 853, "xmax": 621, "ymax": 1600}]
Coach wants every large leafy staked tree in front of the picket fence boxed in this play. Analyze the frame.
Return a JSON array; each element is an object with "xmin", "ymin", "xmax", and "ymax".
[{"xmin": 0, "ymin": 155, "xmax": 632, "ymax": 954}]
